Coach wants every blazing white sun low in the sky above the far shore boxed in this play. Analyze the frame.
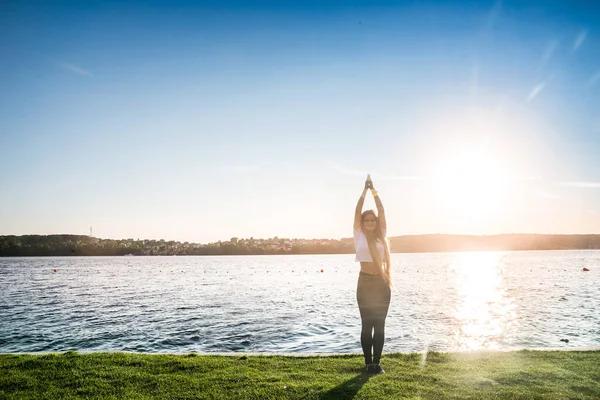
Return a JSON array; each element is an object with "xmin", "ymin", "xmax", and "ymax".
[{"xmin": 430, "ymin": 148, "xmax": 514, "ymax": 233}]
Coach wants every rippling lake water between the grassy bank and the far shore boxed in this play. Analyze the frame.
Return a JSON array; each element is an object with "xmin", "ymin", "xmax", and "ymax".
[{"xmin": 0, "ymin": 250, "xmax": 600, "ymax": 353}]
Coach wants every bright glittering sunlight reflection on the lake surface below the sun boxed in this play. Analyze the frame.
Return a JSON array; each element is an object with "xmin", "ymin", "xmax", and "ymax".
[{"xmin": 449, "ymin": 252, "xmax": 516, "ymax": 350}]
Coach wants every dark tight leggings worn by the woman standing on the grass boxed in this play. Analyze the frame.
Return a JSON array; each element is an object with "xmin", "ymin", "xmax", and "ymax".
[{"xmin": 356, "ymin": 272, "xmax": 391, "ymax": 364}]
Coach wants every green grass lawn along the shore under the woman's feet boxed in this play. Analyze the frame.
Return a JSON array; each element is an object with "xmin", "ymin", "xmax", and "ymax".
[{"xmin": 0, "ymin": 350, "xmax": 600, "ymax": 400}]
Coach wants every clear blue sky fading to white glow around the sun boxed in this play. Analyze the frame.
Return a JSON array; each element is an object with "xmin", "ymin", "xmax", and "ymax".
[{"xmin": 0, "ymin": 0, "xmax": 600, "ymax": 243}]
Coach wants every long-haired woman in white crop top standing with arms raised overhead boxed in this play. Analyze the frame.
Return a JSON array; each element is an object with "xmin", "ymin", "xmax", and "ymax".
[{"xmin": 354, "ymin": 176, "xmax": 391, "ymax": 374}]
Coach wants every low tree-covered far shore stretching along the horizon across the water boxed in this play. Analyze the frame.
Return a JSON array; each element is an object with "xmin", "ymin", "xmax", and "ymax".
[{"xmin": 0, "ymin": 234, "xmax": 600, "ymax": 257}]
